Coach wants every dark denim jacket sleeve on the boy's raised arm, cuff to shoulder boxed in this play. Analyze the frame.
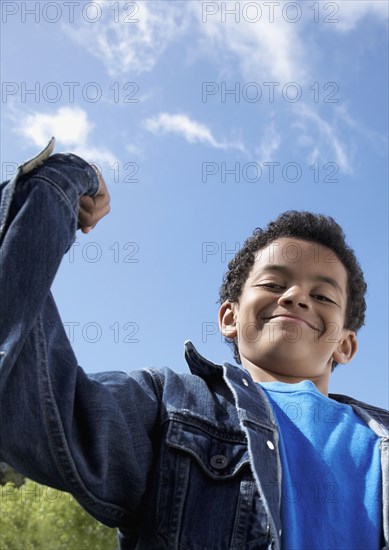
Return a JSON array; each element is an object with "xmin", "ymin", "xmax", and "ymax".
[{"xmin": 0, "ymin": 151, "xmax": 160, "ymax": 527}]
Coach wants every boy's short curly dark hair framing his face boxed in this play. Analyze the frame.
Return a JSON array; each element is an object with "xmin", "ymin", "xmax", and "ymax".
[{"xmin": 219, "ymin": 210, "xmax": 367, "ymax": 370}]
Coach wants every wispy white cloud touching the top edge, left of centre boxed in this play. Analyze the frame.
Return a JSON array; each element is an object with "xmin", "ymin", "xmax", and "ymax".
[{"xmin": 64, "ymin": 0, "xmax": 187, "ymax": 77}]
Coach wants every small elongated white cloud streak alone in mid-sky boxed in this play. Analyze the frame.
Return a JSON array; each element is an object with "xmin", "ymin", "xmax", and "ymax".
[{"xmin": 144, "ymin": 113, "xmax": 244, "ymax": 151}]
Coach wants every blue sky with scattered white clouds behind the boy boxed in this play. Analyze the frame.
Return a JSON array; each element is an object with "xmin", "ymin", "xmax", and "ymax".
[{"xmin": 1, "ymin": 0, "xmax": 388, "ymax": 407}]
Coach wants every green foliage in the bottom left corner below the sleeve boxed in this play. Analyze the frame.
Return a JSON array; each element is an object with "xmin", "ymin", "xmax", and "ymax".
[{"xmin": 0, "ymin": 480, "xmax": 117, "ymax": 550}]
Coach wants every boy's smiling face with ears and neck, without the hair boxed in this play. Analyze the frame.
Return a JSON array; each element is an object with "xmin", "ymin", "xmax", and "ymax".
[{"xmin": 219, "ymin": 238, "xmax": 357, "ymax": 393}]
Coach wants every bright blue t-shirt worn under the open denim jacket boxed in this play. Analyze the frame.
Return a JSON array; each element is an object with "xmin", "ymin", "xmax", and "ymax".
[{"xmin": 260, "ymin": 380, "xmax": 382, "ymax": 550}]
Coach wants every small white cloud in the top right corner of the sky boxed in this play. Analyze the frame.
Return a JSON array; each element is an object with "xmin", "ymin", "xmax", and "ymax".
[{"xmin": 331, "ymin": 0, "xmax": 389, "ymax": 32}]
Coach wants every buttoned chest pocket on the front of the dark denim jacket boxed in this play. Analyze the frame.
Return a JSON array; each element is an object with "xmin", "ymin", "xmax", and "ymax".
[{"xmin": 156, "ymin": 413, "xmax": 268, "ymax": 550}]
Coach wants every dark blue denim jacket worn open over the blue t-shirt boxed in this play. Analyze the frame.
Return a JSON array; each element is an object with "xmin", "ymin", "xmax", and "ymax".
[{"xmin": 0, "ymin": 143, "xmax": 389, "ymax": 550}]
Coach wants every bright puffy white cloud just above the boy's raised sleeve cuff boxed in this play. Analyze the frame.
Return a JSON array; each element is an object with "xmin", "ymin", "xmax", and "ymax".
[{"xmin": 16, "ymin": 107, "xmax": 116, "ymax": 165}]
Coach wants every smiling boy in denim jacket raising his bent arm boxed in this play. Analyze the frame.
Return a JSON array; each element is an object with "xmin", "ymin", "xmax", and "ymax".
[{"xmin": 0, "ymin": 142, "xmax": 389, "ymax": 550}]
